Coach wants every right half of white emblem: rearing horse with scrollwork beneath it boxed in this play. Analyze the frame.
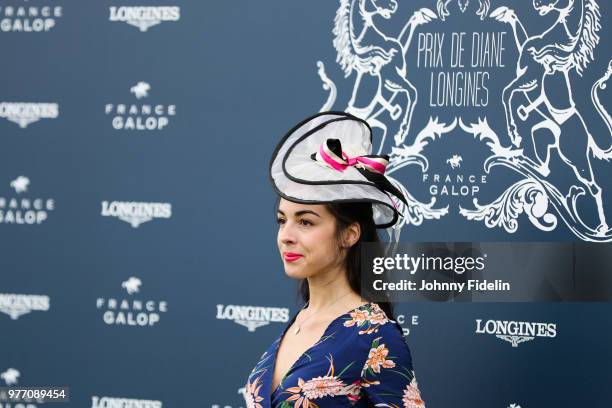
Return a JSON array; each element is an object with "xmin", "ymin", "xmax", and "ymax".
[{"xmin": 460, "ymin": 0, "xmax": 612, "ymax": 241}]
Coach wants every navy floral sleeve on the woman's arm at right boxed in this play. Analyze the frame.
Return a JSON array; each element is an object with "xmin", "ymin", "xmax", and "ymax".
[{"xmin": 361, "ymin": 322, "xmax": 425, "ymax": 408}]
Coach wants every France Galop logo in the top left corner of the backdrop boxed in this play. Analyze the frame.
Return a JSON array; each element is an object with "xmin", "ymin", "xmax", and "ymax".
[{"xmin": 0, "ymin": 2, "xmax": 62, "ymax": 33}]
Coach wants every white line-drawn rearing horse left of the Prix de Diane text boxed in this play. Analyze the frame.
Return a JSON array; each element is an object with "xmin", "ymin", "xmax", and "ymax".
[{"xmin": 333, "ymin": 0, "xmax": 436, "ymax": 151}]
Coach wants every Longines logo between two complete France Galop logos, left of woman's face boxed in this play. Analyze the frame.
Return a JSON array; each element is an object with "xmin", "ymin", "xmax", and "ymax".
[{"xmin": 100, "ymin": 201, "xmax": 172, "ymax": 228}]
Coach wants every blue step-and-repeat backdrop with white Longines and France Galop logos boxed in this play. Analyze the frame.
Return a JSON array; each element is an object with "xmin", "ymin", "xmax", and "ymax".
[{"xmin": 0, "ymin": 0, "xmax": 612, "ymax": 408}]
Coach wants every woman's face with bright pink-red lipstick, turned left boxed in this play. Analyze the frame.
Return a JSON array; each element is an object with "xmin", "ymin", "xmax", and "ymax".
[{"xmin": 276, "ymin": 198, "xmax": 340, "ymax": 279}]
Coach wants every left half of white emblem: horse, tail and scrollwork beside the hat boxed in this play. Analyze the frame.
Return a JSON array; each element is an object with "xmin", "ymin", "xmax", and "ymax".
[{"xmin": 317, "ymin": 0, "xmax": 448, "ymax": 242}]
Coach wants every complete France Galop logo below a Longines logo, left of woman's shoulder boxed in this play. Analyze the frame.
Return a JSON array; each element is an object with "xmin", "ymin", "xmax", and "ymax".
[{"xmin": 96, "ymin": 276, "xmax": 168, "ymax": 327}]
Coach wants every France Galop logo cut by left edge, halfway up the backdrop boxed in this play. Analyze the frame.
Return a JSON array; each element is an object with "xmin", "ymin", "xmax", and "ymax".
[{"xmin": 0, "ymin": 176, "xmax": 55, "ymax": 225}]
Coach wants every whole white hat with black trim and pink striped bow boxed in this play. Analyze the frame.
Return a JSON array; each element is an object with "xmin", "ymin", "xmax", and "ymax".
[{"xmin": 270, "ymin": 111, "xmax": 407, "ymax": 228}]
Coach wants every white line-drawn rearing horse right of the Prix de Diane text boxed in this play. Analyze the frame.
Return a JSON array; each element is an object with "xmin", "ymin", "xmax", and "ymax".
[{"xmin": 491, "ymin": 0, "xmax": 612, "ymax": 233}]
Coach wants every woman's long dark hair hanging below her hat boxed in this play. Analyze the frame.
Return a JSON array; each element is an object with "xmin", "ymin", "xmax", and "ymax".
[{"xmin": 277, "ymin": 198, "xmax": 395, "ymax": 320}]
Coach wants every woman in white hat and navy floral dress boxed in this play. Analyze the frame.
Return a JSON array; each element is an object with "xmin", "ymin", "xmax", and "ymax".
[{"xmin": 245, "ymin": 112, "xmax": 425, "ymax": 408}]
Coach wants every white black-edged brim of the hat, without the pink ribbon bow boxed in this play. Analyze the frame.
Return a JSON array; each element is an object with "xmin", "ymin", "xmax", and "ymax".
[{"xmin": 269, "ymin": 111, "xmax": 399, "ymax": 228}]
